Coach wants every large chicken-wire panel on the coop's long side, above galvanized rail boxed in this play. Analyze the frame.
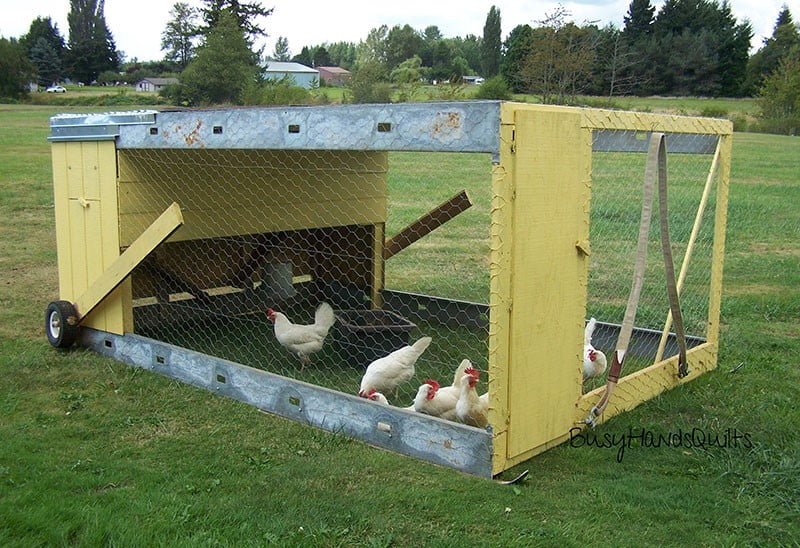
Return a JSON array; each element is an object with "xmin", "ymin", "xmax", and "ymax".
[{"xmin": 119, "ymin": 149, "xmax": 491, "ymax": 406}]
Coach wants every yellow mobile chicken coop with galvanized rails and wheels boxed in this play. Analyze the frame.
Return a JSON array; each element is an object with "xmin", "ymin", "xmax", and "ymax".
[{"xmin": 45, "ymin": 101, "xmax": 732, "ymax": 477}]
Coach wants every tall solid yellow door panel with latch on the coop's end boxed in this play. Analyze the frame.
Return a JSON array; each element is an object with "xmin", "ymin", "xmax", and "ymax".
[{"xmin": 507, "ymin": 106, "xmax": 592, "ymax": 458}]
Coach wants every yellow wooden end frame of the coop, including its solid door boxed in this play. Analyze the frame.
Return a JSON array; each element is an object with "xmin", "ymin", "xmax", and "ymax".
[{"xmin": 489, "ymin": 103, "xmax": 732, "ymax": 474}]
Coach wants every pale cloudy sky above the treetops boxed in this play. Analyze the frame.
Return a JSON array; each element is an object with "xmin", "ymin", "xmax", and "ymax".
[{"xmin": 0, "ymin": 0, "xmax": 800, "ymax": 61}]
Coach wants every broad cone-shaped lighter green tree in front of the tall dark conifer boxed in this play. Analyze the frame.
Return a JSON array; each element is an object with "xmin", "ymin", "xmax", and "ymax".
[{"xmin": 180, "ymin": 13, "xmax": 259, "ymax": 104}]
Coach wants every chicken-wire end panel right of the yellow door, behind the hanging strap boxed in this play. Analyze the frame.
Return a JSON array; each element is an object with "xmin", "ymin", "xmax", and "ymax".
[{"xmin": 586, "ymin": 131, "xmax": 716, "ymax": 388}]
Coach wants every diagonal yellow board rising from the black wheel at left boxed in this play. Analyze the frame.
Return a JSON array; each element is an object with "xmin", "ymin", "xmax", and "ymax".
[{"xmin": 74, "ymin": 204, "xmax": 183, "ymax": 322}]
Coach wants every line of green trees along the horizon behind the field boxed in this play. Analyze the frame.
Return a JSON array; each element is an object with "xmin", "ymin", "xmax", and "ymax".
[{"xmin": 0, "ymin": 0, "xmax": 800, "ymax": 129}]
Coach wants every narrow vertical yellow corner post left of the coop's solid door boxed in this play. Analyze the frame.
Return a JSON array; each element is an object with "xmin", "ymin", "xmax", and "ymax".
[{"xmin": 488, "ymin": 112, "xmax": 514, "ymax": 474}]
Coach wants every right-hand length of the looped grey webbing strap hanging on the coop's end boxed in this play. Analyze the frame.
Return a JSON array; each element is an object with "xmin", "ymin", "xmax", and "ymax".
[{"xmin": 658, "ymin": 135, "xmax": 689, "ymax": 378}]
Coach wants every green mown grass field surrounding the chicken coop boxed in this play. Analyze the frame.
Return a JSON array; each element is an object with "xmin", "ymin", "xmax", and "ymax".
[{"xmin": 0, "ymin": 101, "xmax": 800, "ymax": 546}]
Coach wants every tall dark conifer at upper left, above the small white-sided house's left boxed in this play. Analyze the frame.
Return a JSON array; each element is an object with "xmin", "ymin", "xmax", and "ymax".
[{"xmin": 67, "ymin": 0, "xmax": 119, "ymax": 82}]
